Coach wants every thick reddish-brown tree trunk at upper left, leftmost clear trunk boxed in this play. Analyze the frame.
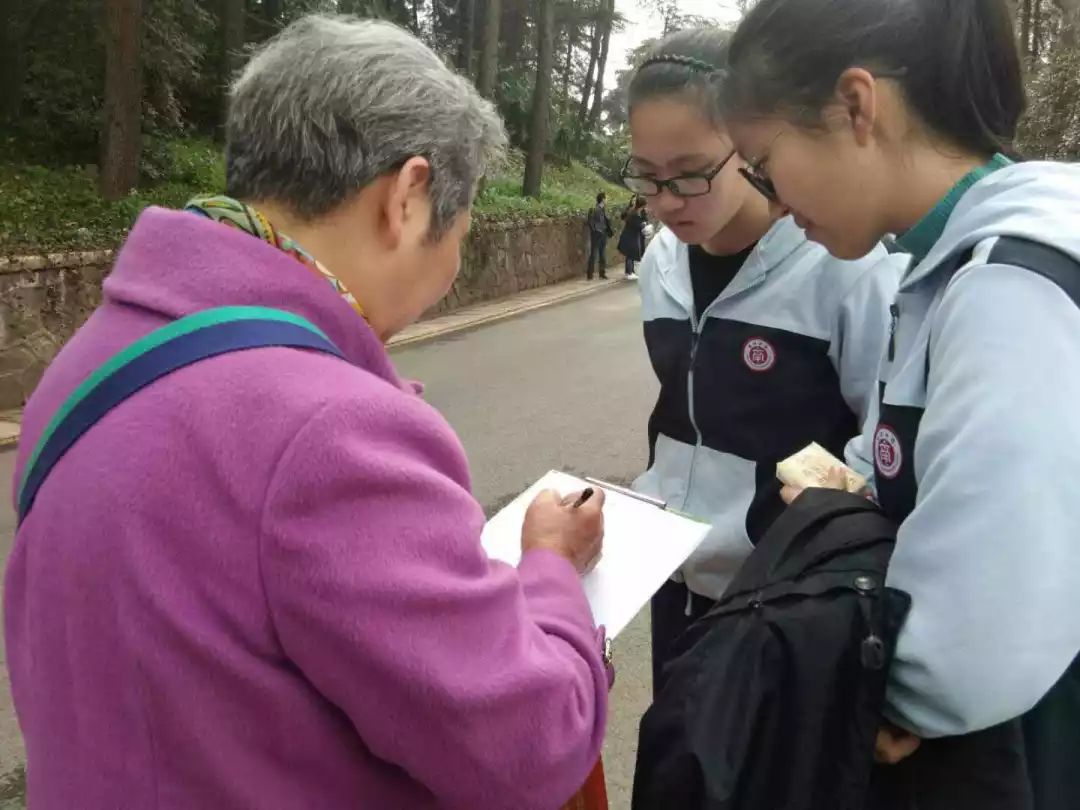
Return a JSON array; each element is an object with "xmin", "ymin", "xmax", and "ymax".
[{"xmin": 100, "ymin": 0, "xmax": 143, "ymax": 200}]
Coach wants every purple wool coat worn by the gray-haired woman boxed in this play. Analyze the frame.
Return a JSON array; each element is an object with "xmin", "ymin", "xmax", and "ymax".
[{"xmin": 4, "ymin": 210, "xmax": 607, "ymax": 810}]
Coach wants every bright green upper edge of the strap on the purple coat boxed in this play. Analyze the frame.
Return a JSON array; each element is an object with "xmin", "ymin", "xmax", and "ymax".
[{"xmin": 18, "ymin": 307, "xmax": 329, "ymax": 491}]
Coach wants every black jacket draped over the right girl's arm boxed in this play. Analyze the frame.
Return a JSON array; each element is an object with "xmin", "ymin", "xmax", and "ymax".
[{"xmin": 633, "ymin": 489, "xmax": 910, "ymax": 810}]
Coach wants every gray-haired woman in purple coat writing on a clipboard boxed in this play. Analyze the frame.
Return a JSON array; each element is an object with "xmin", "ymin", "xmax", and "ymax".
[{"xmin": 4, "ymin": 17, "xmax": 608, "ymax": 810}]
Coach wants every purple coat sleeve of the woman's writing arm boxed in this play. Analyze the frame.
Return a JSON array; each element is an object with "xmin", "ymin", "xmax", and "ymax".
[{"xmin": 253, "ymin": 387, "xmax": 607, "ymax": 810}]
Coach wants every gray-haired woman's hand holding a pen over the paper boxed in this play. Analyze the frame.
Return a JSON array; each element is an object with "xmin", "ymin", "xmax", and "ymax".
[{"xmin": 522, "ymin": 488, "xmax": 604, "ymax": 573}]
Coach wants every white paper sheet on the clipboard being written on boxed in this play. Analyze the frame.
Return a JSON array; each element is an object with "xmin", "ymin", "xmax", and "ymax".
[{"xmin": 483, "ymin": 472, "xmax": 708, "ymax": 638}]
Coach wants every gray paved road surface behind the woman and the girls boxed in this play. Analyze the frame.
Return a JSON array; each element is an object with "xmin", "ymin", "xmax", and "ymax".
[{"xmin": 0, "ymin": 286, "xmax": 656, "ymax": 810}]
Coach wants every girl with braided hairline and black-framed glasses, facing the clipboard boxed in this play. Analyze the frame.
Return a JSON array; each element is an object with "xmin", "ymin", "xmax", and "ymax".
[{"xmin": 623, "ymin": 28, "xmax": 903, "ymax": 692}]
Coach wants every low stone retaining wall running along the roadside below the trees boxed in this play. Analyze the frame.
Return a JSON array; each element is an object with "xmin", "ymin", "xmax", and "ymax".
[{"xmin": 0, "ymin": 217, "xmax": 617, "ymax": 410}]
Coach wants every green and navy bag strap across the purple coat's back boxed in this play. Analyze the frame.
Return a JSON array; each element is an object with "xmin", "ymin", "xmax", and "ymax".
[{"xmin": 16, "ymin": 307, "xmax": 345, "ymax": 524}]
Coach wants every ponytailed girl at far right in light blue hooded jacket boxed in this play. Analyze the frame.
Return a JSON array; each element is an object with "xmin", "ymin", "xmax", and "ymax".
[{"xmin": 723, "ymin": 0, "xmax": 1080, "ymax": 810}]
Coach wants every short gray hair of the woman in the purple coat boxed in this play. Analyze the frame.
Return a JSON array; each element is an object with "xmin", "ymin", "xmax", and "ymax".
[{"xmin": 226, "ymin": 15, "xmax": 507, "ymax": 237}]
